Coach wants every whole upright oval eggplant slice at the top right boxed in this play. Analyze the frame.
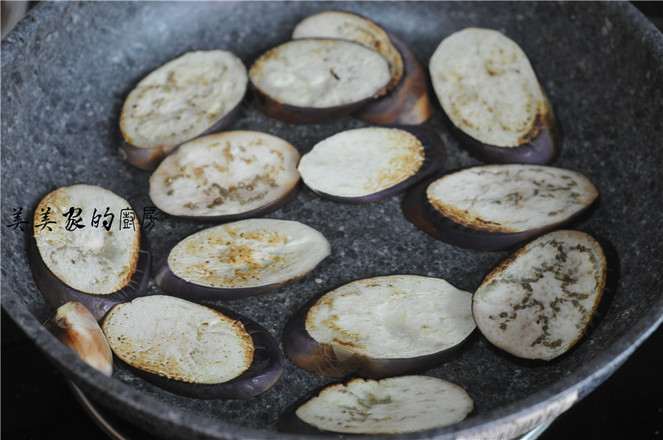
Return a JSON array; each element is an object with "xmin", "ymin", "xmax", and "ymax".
[{"xmin": 429, "ymin": 28, "xmax": 561, "ymax": 164}]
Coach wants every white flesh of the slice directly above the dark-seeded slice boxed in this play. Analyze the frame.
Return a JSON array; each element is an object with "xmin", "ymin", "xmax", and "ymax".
[{"xmin": 426, "ymin": 164, "xmax": 598, "ymax": 233}]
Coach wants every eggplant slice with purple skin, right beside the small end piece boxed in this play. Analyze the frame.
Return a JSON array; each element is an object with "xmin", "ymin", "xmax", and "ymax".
[{"xmin": 103, "ymin": 295, "xmax": 283, "ymax": 399}]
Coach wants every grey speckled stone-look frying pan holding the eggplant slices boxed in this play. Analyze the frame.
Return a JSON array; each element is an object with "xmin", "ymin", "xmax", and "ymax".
[{"xmin": 1, "ymin": 2, "xmax": 663, "ymax": 439}]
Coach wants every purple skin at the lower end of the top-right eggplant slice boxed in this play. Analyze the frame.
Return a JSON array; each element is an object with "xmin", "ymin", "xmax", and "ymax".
[{"xmin": 443, "ymin": 96, "xmax": 563, "ymax": 165}]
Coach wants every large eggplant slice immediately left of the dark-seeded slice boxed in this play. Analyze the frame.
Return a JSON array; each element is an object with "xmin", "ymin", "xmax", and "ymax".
[{"xmin": 283, "ymin": 275, "xmax": 475, "ymax": 378}]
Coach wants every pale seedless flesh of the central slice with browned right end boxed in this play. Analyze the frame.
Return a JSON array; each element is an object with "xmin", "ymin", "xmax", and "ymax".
[{"xmin": 298, "ymin": 127, "xmax": 425, "ymax": 198}]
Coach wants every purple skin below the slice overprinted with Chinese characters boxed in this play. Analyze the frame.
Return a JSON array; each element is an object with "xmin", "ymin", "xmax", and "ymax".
[{"xmin": 28, "ymin": 234, "xmax": 152, "ymax": 321}]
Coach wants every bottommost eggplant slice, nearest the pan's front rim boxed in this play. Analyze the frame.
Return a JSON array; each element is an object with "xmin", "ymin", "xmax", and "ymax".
[{"xmin": 278, "ymin": 376, "xmax": 474, "ymax": 435}]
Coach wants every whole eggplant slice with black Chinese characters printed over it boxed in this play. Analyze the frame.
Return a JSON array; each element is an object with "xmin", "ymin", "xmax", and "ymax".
[{"xmin": 28, "ymin": 184, "xmax": 150, "ymax": 320}]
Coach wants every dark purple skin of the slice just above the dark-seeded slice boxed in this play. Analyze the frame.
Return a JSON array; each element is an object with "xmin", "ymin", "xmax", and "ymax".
[{"xmin": 401, "ymin": 170, "xmax": 591, "ymax": 251}]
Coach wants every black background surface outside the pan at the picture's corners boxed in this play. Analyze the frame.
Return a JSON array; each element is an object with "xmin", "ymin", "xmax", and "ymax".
[{"xmin": 0, "ymin": 2, "xmax": 663, "ymax": 440}]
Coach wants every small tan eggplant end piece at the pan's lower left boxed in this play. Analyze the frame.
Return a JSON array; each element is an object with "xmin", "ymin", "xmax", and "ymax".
[{"xmin": 46, "ymin": 301, "xmax": 113, "ymax": 376}]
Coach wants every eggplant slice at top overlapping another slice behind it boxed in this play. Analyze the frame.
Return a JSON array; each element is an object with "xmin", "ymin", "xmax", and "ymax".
[{"xmin": 249, "ymin": 38, "xmax": 391, "ymax": 123}]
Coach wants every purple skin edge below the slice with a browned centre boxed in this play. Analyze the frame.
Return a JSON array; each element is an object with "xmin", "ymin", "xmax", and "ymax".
[{"xmin": 154, "ymin": 248, "xmax": 291, "ymax": 301}]
